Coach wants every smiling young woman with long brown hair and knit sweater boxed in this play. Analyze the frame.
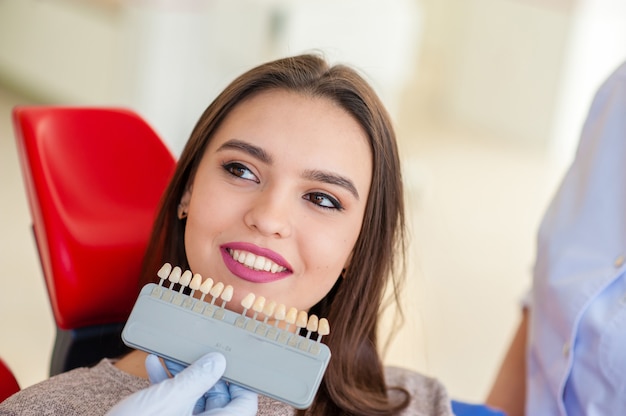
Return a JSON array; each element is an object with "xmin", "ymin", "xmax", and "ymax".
[{"xmin": 0, "ymin": 55, "xmax": 452, "ymax": 415}]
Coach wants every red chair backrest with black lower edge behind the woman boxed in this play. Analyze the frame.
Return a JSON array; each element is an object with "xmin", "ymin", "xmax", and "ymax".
[{"xmin": 13, "ymin": 106, "xmax": 175, "ymax": 375}]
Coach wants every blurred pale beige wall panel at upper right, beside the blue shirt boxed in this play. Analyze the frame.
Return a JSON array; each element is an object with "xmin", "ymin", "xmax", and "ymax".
[{"xmin": 414, "ymin": 0, "xmax": 571, "ymax": 146}]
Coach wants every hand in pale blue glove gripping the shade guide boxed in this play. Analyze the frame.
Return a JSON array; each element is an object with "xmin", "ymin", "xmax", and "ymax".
[{"xmin": 107, "ymin": 353, "xmax": 258, "ymax": 416}]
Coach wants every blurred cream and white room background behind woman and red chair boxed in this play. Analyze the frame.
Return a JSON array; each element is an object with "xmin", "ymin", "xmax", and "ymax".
[{"xmin": 0, "ymin": 0, "xmax": 626, "ymax": 402}]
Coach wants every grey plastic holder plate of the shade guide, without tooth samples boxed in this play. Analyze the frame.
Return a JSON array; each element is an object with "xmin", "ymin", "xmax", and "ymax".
[{"xmin": 122, "ymin": 283, "xmax": 330, "ymax": 409}]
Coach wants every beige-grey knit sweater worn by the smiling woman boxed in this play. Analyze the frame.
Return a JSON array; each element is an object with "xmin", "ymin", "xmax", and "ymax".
[{"xmin": 0, "ymin": 359, "xmax": 452, "ymax": 416}]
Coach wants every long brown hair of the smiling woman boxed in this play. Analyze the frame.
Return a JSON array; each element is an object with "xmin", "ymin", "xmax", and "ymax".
[{"xmin": 141, "ymin": 55, "xmax": 409, "ymax": 415}]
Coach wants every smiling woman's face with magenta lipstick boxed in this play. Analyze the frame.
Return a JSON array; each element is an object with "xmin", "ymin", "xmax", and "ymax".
[{"xmin": 182, "ymin": 90, "xmax": 372, "ymax": 310}]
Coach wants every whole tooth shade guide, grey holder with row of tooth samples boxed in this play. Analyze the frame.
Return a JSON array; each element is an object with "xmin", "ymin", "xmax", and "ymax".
[{"xmin": 123, "ymin": 264, "xmax": 330, "ymax": 409}]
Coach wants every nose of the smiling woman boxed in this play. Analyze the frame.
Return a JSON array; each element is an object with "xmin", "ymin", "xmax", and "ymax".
[{"xmin": 244, "ymin": 189, "xmax": 295, "ymax": 238}]
